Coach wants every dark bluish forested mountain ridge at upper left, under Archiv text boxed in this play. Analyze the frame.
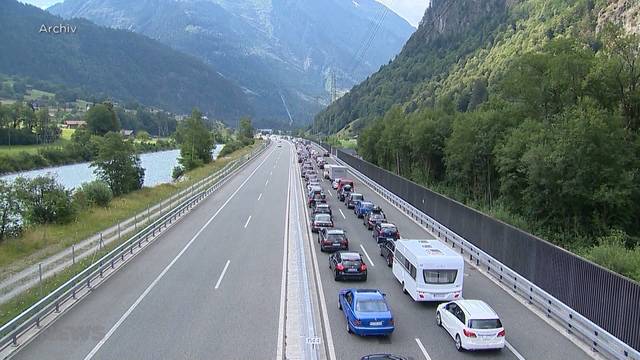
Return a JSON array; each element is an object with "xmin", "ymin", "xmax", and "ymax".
[{"xmin": 0, "ymin": 0, "xmax": 252, "ymax": 120}]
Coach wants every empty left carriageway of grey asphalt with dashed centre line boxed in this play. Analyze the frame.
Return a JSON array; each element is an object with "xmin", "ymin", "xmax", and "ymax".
[{"xmin": 15, "ymin": 146, "xmax": 293, "ymax": 360}]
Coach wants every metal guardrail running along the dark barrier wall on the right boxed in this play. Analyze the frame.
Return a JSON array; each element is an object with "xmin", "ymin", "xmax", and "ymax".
[{"xmin": 335, "ymin": 149, "xmax": 640, "ymax": 360}]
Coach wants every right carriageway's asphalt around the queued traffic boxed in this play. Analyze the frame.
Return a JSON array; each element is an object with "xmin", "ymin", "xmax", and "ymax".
[{"xmin": 308, "ymin": 144, "xmax": 591, "ymax": 360}]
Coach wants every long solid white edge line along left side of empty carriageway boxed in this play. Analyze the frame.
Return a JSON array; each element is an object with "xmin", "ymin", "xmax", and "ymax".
[{"xmin": 84, "ymin": 147, "xmax": 273, "ymax": 360}]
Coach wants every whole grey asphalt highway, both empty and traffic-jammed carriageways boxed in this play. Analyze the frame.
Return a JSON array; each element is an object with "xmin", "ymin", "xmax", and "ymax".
[{"xmin": 14, "ymin": 141, "xmax": 590, "ymax": 360}]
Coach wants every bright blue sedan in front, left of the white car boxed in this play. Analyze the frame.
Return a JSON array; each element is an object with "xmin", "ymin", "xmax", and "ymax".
[{"xmin": 338, "ymin": 289, "xmax": 395, "ymax": 336}]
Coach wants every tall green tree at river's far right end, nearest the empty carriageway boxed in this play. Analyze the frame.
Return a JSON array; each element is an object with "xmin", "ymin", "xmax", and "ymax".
[{"xmin": 176, "ymin": 110, "xmax": 214, "ymax": 170}]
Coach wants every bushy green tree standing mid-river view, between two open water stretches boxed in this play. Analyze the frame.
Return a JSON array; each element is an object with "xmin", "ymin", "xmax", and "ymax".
[{"xmin": 91, "ymin": 132, "xmax": 144, "ymax": 196}]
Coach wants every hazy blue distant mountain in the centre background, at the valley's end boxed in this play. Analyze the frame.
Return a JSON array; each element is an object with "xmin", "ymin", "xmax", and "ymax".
[{"xmin": 48, "ymin": 0, "xmax": 414, "ymax": 124}]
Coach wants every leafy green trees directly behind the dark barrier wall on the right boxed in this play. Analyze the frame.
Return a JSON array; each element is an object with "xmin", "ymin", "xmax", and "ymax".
[{"xmin": 358, "ymin": 25, "xmax": 640, "ymax": 280}]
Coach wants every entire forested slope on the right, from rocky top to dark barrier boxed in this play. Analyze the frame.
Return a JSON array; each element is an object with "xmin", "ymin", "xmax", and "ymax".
[{"xmin": 312, "ymin": 0, "xmax": 640, "ymax": 279}]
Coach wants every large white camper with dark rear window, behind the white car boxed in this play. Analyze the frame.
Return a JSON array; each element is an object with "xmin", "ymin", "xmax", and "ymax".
[{"xmin": 393, "ymin": 240, "xmax": 464, "ymax": 301}]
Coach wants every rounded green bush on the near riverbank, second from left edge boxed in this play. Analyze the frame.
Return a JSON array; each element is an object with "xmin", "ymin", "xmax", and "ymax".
[{"xmin": 14, "ymin": 176, "xmax": 75, "ymax": 224}]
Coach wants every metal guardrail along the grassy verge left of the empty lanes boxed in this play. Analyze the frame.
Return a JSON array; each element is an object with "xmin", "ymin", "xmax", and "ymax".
[{"xmin": 0, "ymin": 143, "xmax": 268, "ymax": 354}]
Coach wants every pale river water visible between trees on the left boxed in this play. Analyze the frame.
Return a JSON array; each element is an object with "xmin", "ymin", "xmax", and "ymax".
[{"xmin": 1, "ymin": 145, "xmax": 223, "ymax": 189}]
